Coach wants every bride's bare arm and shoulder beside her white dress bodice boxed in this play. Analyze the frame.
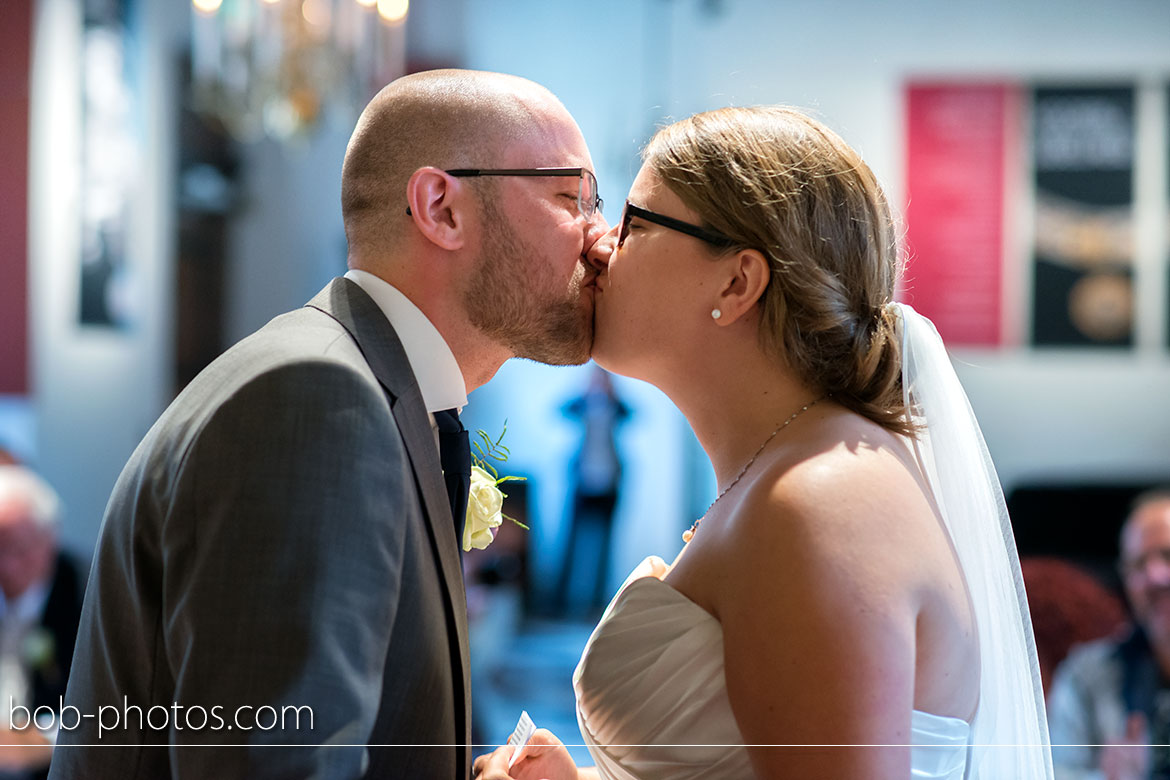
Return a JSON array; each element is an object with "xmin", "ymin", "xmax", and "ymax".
[{"xmin": 715, "ymin": 454, "xmax": 916, "ymax": 780}]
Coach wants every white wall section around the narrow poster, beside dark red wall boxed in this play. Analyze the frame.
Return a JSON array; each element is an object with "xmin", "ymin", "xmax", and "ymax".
[{"xmin": 29, "ymin": 0, "xmax": 181, "ymax": 553}]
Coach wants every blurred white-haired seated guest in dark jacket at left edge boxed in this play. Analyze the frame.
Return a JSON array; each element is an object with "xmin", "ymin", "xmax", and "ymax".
[{"xmin": 0, "ymin": 465, "xmax": 81, "ymax": 780}]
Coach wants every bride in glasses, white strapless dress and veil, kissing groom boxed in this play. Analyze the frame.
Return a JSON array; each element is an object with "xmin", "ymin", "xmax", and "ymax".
[{"xmin": 476, "ymin": 106, "xmax": 1052, "ymax": 780}]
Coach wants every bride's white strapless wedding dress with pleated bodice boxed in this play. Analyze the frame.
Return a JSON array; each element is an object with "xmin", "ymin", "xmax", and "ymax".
[{"xmin": 573, "ymin": 557, "xmax": 971, "ymax": 780}]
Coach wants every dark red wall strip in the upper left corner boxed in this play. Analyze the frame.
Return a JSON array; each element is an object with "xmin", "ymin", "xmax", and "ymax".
[{"xmin": 0, "ymin": 0, "xmax": 34, "ymax": 395}]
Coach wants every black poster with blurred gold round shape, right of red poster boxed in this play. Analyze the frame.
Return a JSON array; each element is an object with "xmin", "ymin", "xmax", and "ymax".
[{"xmin": 1032, "ymin": 85, "xmax": 1135, "ymax": 347}]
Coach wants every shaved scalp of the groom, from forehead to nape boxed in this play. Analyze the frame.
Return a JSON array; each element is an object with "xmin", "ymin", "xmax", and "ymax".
[{"xmin": 342, "ymin": 70, "xmax": 571, "ymax": 263}]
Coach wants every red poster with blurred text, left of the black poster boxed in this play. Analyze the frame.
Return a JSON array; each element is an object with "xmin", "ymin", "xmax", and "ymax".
[{"xmin": 900, "ymin": 83, "xmax": 1019, "ymax": 346}]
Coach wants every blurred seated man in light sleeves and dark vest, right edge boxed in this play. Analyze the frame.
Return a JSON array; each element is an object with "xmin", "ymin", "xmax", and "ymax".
[{"xmin": 1048, "ymin": 490, "xmax": 1170, "ymax": 780}]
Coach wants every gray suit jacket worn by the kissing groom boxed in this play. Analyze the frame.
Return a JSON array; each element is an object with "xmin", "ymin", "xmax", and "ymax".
[{"xmin": 49, "ymin": 278, "xmax": 470, "ymax": 780}]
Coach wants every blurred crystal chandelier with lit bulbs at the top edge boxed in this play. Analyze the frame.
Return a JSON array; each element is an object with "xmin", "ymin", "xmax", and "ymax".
[{"xmin": 191, "ymin": 0, "xmax": 408, "ymax": 141}]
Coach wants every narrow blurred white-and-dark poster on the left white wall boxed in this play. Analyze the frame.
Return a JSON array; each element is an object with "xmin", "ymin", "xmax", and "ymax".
[{"xmin": 78, "ymin": 0, "xmax": 142, "ymax": 329}]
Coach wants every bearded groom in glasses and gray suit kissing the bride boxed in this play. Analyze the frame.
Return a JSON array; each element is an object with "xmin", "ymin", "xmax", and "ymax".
[{"xmin": 50, "ymin": 70, "xmax": 606, "ymax": 780}]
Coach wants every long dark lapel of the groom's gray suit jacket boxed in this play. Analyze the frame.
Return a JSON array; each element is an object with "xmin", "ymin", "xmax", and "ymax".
[{"xmin": 308, "ymin": 278, "xmax": 470, "ymax": 750}]
